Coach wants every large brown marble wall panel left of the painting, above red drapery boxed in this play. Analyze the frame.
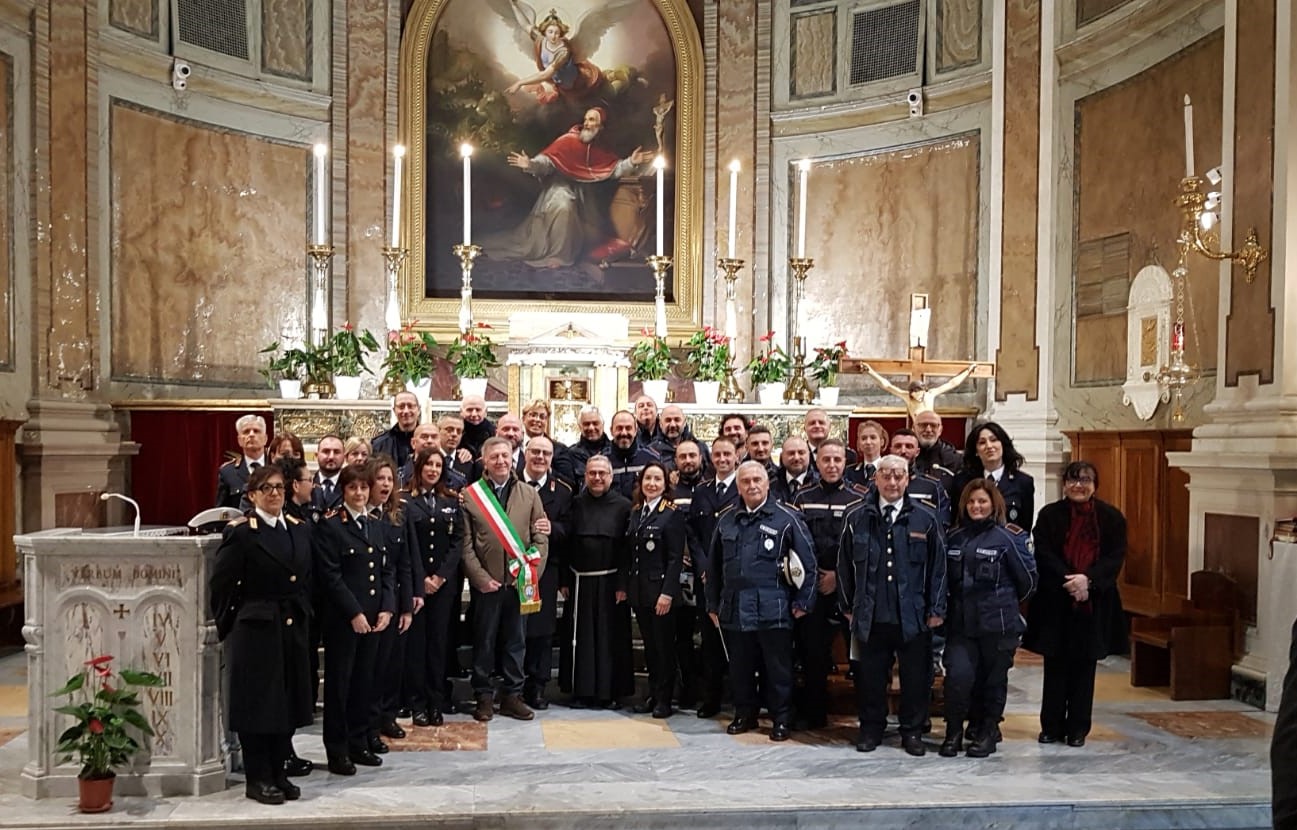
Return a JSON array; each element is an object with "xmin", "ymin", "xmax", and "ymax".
[{"xmin": 109, "ymin": 102, "xmax": 309, "ymax": 385}]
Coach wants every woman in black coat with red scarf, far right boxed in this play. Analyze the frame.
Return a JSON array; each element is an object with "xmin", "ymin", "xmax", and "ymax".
[{"xmin": 1022, "ymin": 462, "xmax": 1126, "ymax": 747}]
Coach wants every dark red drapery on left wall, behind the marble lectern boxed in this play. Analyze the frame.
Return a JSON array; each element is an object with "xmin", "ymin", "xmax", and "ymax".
[{"xmin": 131, "ymin": 410, "xmax": 275, "ymax": 524}]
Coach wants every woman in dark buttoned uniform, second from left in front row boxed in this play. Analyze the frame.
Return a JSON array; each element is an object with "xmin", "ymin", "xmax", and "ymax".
[{"xmin": 315, "ymin": 467, "xmax": 396, "ymax": 776}]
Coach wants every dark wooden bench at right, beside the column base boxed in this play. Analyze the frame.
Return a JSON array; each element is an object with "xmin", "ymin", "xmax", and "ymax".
[{"xmin": 1131, "ymin": 571, "xmax": 1243, "ymax": 700}]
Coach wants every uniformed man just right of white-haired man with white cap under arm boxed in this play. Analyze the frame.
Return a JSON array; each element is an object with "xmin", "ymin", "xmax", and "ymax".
[{"xmin": 792, "ymin": 438, "xmax": 866, "ymax": 729}]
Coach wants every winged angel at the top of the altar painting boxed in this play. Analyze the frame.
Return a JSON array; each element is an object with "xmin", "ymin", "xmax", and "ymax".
[{"xmin": 486, "ymin": 0, "xmax": 641, "ymax": 104}]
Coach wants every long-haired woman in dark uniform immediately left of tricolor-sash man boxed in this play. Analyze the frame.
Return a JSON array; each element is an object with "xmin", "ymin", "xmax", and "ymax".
[{"xmin": 401, "ymin": 449, "xmax": 463, "ymax": 726}]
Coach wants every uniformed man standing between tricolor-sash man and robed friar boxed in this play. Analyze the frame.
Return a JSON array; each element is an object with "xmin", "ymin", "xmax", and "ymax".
[{"xmin": 519, "ymin": 436, "xmax": 572, "ymax": 709}]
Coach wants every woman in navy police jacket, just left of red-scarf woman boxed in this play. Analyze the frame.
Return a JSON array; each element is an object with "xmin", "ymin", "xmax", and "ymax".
[{"xmin": 940, "ymin": 479, "xmax": 1036, "ymax": 757}]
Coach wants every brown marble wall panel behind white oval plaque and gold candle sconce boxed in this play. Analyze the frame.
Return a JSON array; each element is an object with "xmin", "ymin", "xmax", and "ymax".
[{"xmin": 1073, "ymin": 31, "xmax": 1224, "ymax": 384}]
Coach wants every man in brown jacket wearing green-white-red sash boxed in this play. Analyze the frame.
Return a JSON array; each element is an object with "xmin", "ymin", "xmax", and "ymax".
[{"xmin": 463, "ymin": 437, "xmax": 550, "ymax": 721}]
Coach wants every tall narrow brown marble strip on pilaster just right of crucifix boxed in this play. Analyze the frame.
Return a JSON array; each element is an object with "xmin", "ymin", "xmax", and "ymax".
[{"xmin": 995, "ymin": 0, "xmax": 1040, "ymax": 401}]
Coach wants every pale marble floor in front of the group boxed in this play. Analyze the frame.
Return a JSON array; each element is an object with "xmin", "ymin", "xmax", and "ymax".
[{"xmin": 0, "ymin": 654, "xmax": 1274, "ymax": 830}]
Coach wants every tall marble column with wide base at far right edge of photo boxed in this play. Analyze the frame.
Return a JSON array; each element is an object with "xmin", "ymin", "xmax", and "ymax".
[{"xmin": 1169, "ymin": 0, "xmax": 1297, "ymax": 708}]
